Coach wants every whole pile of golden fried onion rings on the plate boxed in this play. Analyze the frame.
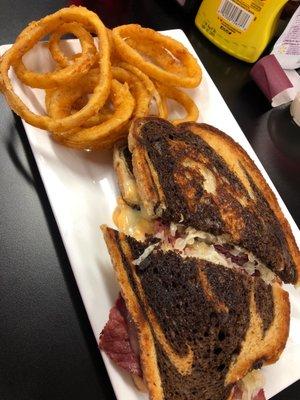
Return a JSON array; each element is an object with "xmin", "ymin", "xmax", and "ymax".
[{"xmin": 0, "ymin": 6, "xmax": 201, "ymax": 149}]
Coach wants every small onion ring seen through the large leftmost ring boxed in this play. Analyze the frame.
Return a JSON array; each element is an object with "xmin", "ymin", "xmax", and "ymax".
[{"xmin": 48, "ymin": 22, "xmax": 96, "ymax": 69}]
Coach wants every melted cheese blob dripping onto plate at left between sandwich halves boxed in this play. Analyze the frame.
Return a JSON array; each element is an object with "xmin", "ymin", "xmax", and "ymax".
[{"xmin": 113, "ymin": 198, "xmax": 154, "ymax": 241}]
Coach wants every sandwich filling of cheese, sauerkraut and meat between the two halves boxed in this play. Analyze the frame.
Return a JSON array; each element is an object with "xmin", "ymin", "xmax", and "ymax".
[{"xmin": 113, "ymin": 198, "xmax": 280, "ymax": 283}]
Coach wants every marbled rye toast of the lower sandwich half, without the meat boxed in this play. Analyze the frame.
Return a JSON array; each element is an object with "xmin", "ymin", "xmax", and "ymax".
[{"xmin": 102, "ymin": 226, "xmax": 290, "ymax": 400}]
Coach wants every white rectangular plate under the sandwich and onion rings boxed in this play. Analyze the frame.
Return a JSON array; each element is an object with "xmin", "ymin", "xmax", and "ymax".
[{"xmin": 0, "ymin": 29, "xmax": 300, "ymax": 400}]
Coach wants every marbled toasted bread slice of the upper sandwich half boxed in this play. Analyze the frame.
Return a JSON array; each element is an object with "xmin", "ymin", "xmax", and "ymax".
[{"xmin": 128, "ymin": 117, "xmax": 300, "ymax": 283}]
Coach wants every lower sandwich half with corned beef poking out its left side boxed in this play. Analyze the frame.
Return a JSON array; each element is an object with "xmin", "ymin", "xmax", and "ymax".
[{"xmin": 100, "ymin": 226, "xmax": 289, "ymax": 400}]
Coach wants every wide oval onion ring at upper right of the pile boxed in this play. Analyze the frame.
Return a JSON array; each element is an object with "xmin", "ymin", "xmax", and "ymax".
[{"xmin": 112, "ymin": 24, "xmax": 202, "ymax": 88}]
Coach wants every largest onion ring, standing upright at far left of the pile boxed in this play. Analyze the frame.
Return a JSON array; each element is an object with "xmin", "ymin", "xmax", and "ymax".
[{"xmin": 0, "ymin": 7, "xmax": 111, "ymax": 132}]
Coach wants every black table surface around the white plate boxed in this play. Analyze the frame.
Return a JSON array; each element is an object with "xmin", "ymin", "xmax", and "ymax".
[{"xmin": 0, "ymin": 0, "xmax": 300, "ymax": 400}]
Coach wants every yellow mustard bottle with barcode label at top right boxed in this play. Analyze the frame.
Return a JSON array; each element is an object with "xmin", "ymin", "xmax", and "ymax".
[{"xmin": 195, "ymin": 0, "xmax": 288, "ymax": 63}]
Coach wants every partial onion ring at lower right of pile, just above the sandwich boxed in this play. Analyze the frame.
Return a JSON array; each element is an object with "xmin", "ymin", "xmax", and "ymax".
[{"xmin": 157, "ymin": 83, "xmax": 199, "ymax": 125}]
